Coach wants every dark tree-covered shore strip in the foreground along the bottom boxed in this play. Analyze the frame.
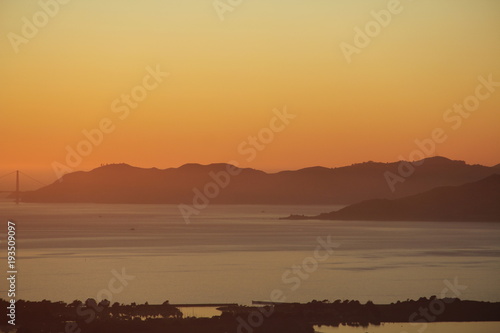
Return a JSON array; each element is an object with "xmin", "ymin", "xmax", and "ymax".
[{"xmin": 0, "ymin": 296, "xmax": 500, "ymax": 333}]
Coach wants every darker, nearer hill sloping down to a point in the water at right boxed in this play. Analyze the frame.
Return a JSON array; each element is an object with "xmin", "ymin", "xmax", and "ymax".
[{"xmin": 286, "ymin": 174, "xmax": 500, "ymax": 222}]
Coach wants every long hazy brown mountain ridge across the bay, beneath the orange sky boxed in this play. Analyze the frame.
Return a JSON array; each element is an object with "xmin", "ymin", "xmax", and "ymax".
[{"xmin": 22, "ymin": 157, "xmax": 500, "ymax": 204}]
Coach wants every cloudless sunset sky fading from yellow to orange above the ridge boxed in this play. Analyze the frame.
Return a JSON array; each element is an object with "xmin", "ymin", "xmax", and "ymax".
[{"xmin": 0, "ymin": 0, "xmax": 500, "ymax": 187}]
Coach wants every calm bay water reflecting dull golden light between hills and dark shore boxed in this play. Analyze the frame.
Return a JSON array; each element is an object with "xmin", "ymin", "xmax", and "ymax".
[{"xmin": 0, "ymin": 202, "xmax": 500, "ymax": 304}]
